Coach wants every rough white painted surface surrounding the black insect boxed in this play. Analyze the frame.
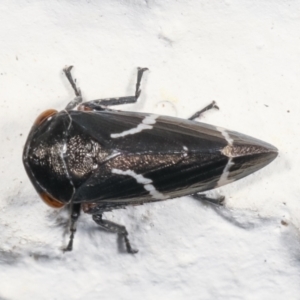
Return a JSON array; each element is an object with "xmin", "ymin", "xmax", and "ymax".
[{"xmin": 0, "ymin": 0, "xmax": 300, "ymax": 300}]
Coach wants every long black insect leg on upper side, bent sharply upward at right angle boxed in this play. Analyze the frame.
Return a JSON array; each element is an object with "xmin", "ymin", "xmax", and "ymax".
[{"xmin": 81, "ymin": 68, "xmax": 148, "ymax": 111}]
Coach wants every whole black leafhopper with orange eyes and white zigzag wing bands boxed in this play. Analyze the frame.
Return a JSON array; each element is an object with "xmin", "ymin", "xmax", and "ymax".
[{"xmin": 23, "ymin": 66, "xmax": 278, "ymax": 253}]
